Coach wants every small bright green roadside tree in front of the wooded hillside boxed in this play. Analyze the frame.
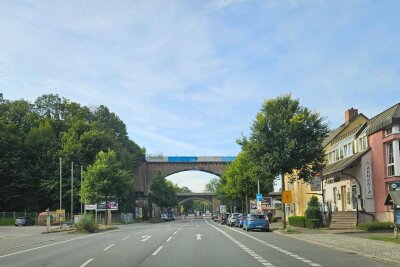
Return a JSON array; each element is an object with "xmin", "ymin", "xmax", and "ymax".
[{"xmin": 82, "ymin": 150, "xmax": 133, "ymax": 224}]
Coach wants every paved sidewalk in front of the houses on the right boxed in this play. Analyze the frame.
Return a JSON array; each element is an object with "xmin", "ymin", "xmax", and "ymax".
[{"xmin": 271, "ymin": 223, "xmax": 400, "ymax": 265}]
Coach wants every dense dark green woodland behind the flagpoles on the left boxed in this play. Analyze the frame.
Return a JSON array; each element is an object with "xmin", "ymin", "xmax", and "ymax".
[{"xmin": 0, "ymin": 94, "xmax": 144, "ymax": 211}]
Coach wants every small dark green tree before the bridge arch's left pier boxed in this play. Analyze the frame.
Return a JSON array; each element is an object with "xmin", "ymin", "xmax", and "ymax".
[{"xmin": 149, "ymin": 172, "xmax": 178, "ymax": 211}]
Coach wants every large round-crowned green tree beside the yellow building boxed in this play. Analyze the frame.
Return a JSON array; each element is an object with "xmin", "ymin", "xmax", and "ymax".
[{"xmin": 240, "ymin": 95, "xmax": 329, "ymax": 228}]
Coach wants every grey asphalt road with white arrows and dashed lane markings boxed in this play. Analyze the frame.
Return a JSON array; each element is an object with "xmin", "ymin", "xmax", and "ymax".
[{"xmin": 0, "ymin": 220, "xmax": 398, "ymax": 267}]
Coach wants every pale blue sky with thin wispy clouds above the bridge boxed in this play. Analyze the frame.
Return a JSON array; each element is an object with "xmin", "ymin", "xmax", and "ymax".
[{"xmin": 0, "ymin": 0, "xmax": 400, "ymax": 193}]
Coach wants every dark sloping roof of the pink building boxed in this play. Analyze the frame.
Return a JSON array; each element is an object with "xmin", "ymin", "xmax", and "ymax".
[{"xmin": 367, "ymin": 103, "xmax": 400, "ymax": 135}]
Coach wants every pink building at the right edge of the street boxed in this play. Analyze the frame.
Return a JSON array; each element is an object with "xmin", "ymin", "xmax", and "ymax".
[{"xmin": 367, "ymin": 103, "xmax": 400, "ymax": 221}]
